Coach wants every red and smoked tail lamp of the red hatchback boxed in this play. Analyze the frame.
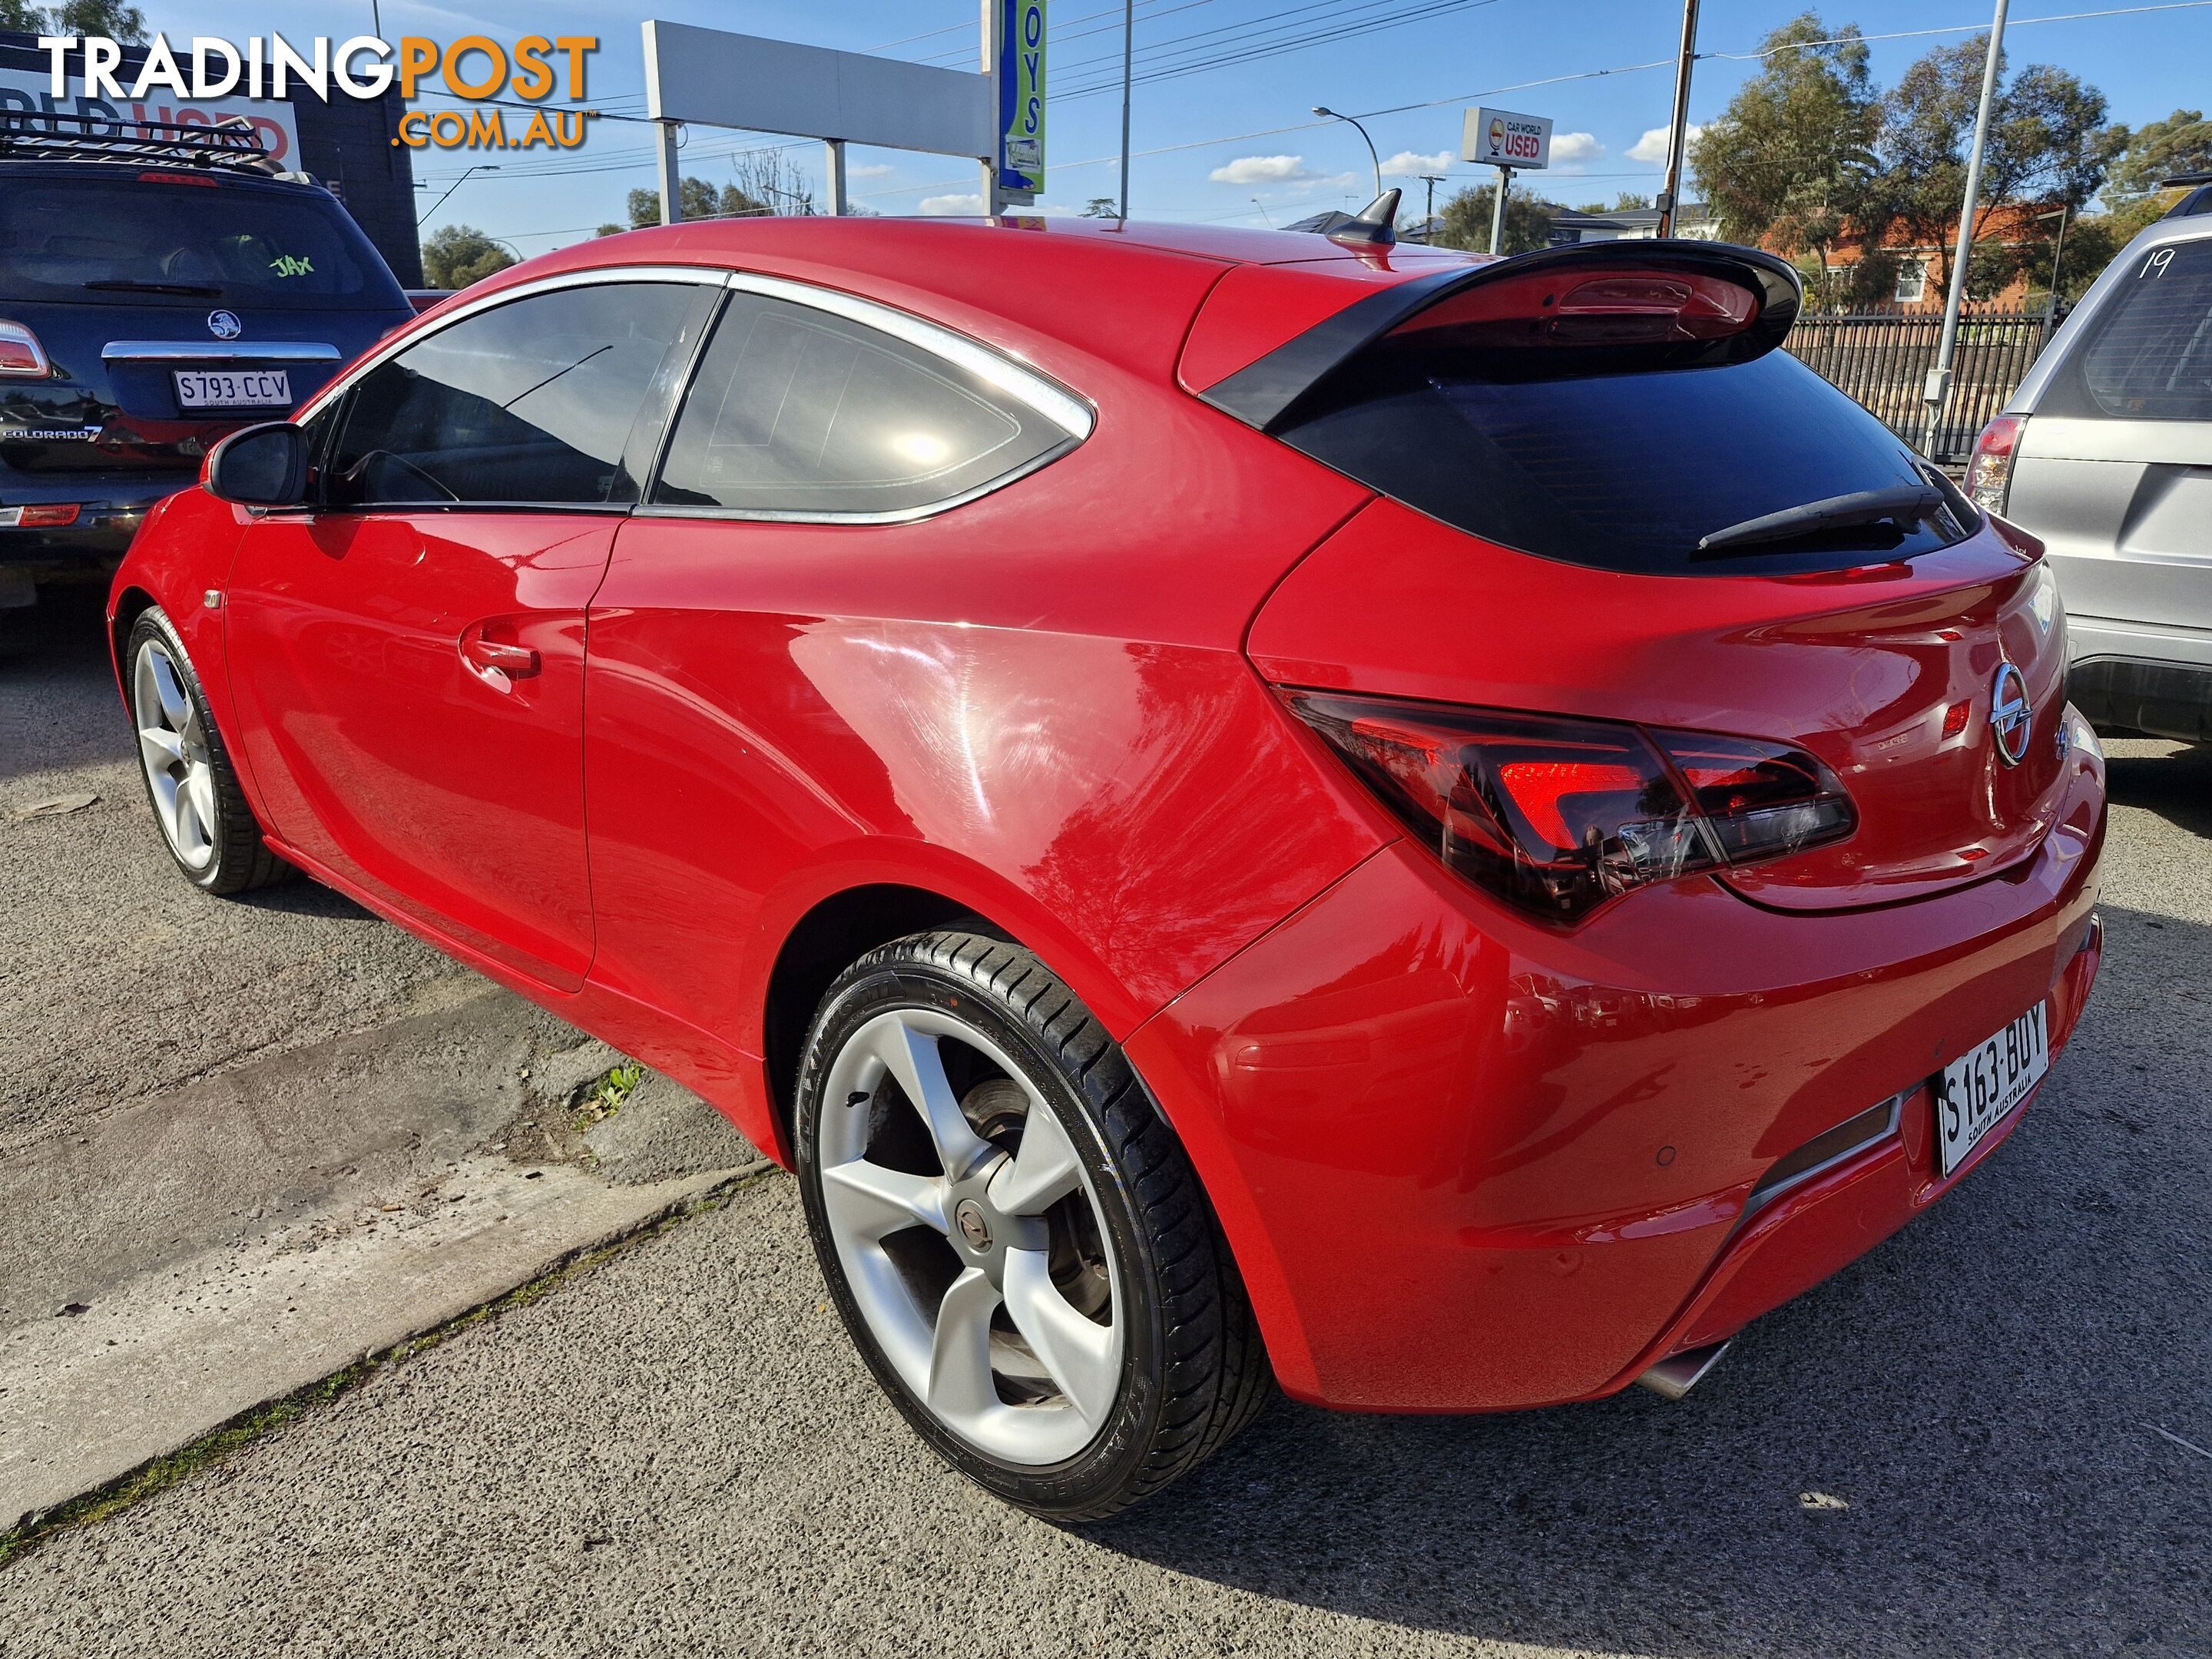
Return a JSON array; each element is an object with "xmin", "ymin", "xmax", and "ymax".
[{"xmin": 1283, "ymin": 690, "xmax": 1858, "ymax": 922}]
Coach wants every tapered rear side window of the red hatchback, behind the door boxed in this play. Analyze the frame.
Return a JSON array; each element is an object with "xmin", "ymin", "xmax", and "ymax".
[{"xmin": 653, "ymin": 292, "xmax": 1068, "ymax": 518}]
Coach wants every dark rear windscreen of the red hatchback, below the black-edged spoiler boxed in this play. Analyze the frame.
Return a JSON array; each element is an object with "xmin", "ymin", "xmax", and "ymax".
[{"xmin": 1279, "ymin": 343, "xmax": 1973, "ymax": 575}]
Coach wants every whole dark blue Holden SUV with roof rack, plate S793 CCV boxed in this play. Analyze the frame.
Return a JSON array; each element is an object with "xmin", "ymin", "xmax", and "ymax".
[{"xmin": 0, "ymin": 111, "xmax": 414, "ymax": 615}]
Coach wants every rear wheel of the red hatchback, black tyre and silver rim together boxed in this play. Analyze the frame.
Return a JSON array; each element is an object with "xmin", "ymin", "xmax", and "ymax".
[{"xmin": 794, "ymin": 933, "xmax": 1272, "ymax": 1522}]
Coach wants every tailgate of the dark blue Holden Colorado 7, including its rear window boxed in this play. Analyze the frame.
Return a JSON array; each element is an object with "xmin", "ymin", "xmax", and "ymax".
[{"xmin": 0, "ymin": 161, "xmax": 412, "ymax": 475}]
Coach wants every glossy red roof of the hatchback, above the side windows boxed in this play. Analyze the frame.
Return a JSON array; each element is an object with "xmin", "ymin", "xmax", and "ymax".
[{"xmin": 465, "ymin": 214, "xmax": 1475, "ymax": 367}]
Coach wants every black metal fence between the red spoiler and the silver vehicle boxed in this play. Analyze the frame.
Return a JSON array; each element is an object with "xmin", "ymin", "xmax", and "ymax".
[{"xmin": 1787, "ymin": 305, "xmax": 2046, "ymax": 465}]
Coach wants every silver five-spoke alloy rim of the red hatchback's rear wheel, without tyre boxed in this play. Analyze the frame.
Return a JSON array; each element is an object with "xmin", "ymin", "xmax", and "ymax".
[{"xmin": 816, "ymin": 1008, "xmax": 1126, "ymax": 1466}]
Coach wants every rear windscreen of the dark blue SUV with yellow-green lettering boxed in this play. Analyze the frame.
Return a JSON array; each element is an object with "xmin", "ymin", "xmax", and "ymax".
[{"xmin": 0, "ymin": 179, "xmax": 407, "ymax": 310}]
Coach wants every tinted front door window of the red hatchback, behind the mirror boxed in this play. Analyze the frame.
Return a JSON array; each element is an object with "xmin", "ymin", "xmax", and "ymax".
[{"xmin": 325, "ymin": 283, "xmax": 712, "ymax": 507}]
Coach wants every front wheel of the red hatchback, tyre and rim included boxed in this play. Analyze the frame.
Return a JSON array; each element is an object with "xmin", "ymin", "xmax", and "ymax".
[{"xmin": 124, "ymin": 606, "xmax": 292, "ymax": 894}]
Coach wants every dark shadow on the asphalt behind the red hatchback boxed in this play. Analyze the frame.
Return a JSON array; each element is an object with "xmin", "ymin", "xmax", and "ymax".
[{"xmin": 1088, "ymin": 909, "xmax": 2212, "ymax": 1654}]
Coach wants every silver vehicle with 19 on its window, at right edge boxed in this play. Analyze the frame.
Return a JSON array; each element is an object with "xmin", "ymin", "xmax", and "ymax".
[{"xmin": 1966, "ymin": 179, "xmax": 2212, "ymax": 743}]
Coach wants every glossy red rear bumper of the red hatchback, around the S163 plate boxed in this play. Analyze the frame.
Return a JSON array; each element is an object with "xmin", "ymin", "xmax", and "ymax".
[{"xmin": 1128, "ymin": 717, "xmax": 2104, "ymax": 1411}]
